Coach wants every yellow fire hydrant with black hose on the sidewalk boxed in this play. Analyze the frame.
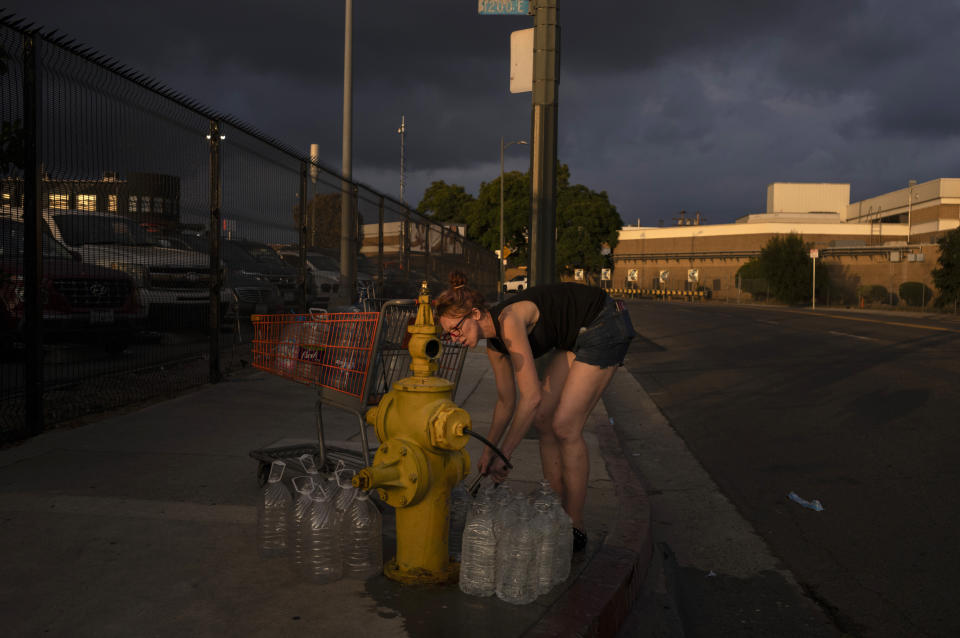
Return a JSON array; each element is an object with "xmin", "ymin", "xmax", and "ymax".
[{"xmin": 353, "ymin": 282, "xmax": 470, "ymax": 584}]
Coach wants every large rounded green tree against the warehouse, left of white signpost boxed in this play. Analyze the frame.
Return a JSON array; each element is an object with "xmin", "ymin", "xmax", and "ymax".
[{"xmin": 759, "ymin": 233, "xmax": 828, "ymax": 304}]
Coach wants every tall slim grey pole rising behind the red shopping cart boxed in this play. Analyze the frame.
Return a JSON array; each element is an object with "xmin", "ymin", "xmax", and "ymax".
[{"xmin": 338, "ymin": 0, "xmax": 356, "ymax": 305}]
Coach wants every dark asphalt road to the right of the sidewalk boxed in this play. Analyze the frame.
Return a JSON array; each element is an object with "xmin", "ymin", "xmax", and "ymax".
[{"xmin": 627, "ymin": 301, "xmax": 960, "ymax": 636}]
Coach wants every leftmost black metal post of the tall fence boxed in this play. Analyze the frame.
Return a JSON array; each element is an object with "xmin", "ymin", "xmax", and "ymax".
[{"xmin": 23, "ymin": 34, "xmax": 43, "ymax": 434}]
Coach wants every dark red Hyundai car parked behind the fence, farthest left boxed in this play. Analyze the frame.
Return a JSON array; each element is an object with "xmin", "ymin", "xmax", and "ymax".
[{"xmin": 0, "ymin": 217, "xmax": 145, "ymax": 353}]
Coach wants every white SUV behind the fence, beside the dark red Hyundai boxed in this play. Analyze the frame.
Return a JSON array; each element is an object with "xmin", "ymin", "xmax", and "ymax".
[{"xmin": 35, "ymin": 210, "xmax": 219, "ymax": 319}]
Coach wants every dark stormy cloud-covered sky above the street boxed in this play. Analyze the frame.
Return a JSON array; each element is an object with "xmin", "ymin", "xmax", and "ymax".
[{"xmin": 5, "ymin": 0, "xmax": 960, "ymax": 226}]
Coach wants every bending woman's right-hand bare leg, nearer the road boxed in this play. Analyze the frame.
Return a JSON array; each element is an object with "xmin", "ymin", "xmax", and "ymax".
[{"xmin": 553, "ymin": 361, "xmax": 616, "ymax": 529}]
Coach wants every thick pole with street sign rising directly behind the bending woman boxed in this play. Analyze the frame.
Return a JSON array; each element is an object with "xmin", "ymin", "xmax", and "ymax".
[{"xmin": 529, "ymin": 0, "xmax": 560, "ymax": 286}]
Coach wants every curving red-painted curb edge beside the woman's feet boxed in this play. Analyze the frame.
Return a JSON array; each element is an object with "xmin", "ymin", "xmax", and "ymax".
[{"xmin": 525, "ymin": 378, "xmax": 653, "ymax": 638}]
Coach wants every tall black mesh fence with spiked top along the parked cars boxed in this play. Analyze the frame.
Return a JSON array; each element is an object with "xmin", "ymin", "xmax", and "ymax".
[{"xmin": 0, "ymin": 15, "xmax": 498, "ymax": 441}]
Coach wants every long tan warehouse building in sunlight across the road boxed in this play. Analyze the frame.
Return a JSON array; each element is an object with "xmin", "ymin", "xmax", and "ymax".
[{"xmin": 610, "ymin": 178, "xmax": 960, "ymax": 304}]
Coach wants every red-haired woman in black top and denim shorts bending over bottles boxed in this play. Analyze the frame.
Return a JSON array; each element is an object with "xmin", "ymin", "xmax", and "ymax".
[{"xmin": 434, "ymin": 272, "xmax": 635, "ymax": 550}]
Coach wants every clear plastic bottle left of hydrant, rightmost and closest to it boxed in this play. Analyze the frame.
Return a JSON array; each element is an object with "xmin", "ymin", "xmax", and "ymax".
[{"xmin": 340, "ymin": 488, "xmax": 383, "ymax": 579}]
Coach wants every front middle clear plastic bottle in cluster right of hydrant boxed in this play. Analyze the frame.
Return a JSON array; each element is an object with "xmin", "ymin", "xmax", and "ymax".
[{"xmin": 497, "ymin": 496, "xmax": 541, "ymax": 605}]
